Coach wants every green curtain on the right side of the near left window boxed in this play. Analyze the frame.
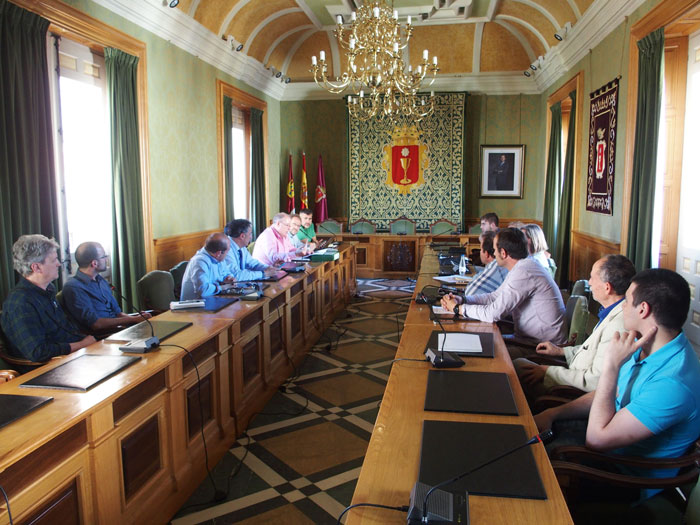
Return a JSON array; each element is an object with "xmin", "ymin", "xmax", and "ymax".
[{"xmin": 105, "ymin": 48, "xmax": 146, "ymax": 309}]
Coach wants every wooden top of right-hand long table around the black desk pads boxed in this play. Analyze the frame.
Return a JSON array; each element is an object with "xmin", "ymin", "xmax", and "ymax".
[{"xmin": 346, "ymin": 249, "xmax": 572, "ymax": 525}]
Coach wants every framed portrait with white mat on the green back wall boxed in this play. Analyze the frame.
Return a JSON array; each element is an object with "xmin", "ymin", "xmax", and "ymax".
[{"xmin": 481, "ymin": 144, "xmax": 525, "ymax": 199}]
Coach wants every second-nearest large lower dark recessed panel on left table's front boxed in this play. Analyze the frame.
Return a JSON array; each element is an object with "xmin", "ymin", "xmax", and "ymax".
[{"xmin": 121, "ymin": 416, "xmax": 161, "ymax": 500}]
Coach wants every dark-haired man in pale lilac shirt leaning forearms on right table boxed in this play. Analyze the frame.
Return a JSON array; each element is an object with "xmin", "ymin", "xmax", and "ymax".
[{"xmin": 442, "ymin": 228, "xmax": 567, "ymax": 348}]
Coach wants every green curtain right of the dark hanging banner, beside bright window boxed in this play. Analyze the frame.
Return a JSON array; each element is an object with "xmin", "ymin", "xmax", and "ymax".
[{"xmin": 627, "ymin": 27, "xmax": 664, "ymax": 271}]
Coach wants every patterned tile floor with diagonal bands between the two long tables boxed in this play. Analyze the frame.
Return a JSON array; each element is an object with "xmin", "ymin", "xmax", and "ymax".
[{"xmin": 171, "ymin": 279, "xmax": 413, "ymax": 525}]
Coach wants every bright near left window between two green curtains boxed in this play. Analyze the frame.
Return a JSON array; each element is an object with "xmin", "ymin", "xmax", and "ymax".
[{"xmin": 49, "ymin": 37, "xmax": 112, "ymax": 279}]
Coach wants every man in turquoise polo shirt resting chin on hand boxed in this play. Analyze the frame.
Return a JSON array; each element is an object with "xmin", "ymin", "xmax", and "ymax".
[{"xmin": 535, "ymin": 269, "xmax": 700, "ymax": 496}]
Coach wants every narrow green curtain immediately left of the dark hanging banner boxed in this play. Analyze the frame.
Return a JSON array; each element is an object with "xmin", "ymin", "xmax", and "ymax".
[{"xmin": 550, "ymin": 91, "xmax": 576, "ymax": 288}]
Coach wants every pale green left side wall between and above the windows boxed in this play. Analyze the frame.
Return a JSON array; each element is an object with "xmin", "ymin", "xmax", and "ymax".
[{"xmin": 60, "ymin": 0, "xmax": 280, "ymax": 238}]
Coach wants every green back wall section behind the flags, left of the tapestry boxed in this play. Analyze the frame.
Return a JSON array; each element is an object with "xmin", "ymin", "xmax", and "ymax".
[{"xmin": 278, "ymin": 100, "xmax": 348, "ymax": 217}]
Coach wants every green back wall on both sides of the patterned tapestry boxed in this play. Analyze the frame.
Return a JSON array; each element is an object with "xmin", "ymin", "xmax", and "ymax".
[{"xmin": 279, "ymin": 95, "xmax": 544, "ymax": 219}]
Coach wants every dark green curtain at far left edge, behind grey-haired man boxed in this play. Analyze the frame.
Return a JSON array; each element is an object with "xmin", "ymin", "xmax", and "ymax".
[{"xmin": 0, "ymin": 0, "xmax": 58, "ymax": 301}]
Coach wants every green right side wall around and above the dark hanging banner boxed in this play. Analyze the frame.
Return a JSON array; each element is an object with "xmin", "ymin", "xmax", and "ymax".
[{"xmin": 540, "ymin": 0, "xmax": 663, "ymax": 242}]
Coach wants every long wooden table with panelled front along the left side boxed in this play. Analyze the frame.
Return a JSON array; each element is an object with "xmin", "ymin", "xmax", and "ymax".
[{"xmin": 0, "ymin": 244, "xmax": 356, "ymax": 525}]
